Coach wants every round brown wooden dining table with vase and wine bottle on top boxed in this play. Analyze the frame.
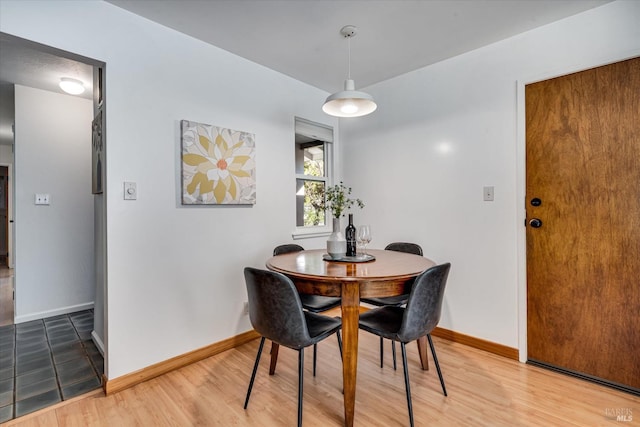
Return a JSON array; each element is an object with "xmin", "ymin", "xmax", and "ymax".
[{"xmin": 266, "ymin": 249, "xmax": 435, "ymax": 427}]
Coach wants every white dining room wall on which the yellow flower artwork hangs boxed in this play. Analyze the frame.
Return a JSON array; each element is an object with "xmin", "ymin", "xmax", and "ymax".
[{"xmin": 0, "ymin": 0, "xmax": 339, "ymax": 379}]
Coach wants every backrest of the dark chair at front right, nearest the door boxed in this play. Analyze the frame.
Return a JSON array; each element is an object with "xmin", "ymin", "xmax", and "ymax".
[{"xmin": 398, "ymin": 263, "xmax": 451, "ymax": 342}]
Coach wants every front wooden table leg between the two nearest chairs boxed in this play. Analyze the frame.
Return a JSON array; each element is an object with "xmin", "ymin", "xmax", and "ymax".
[{"xmin": 342, "ymin": 282, "xmax": 360, "ymax": 427}]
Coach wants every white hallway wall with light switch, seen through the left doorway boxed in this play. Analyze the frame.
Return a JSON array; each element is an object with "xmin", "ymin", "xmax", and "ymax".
[{"xmin": 14, "ymin": 85, "xmax": 95, "ymax": 323}]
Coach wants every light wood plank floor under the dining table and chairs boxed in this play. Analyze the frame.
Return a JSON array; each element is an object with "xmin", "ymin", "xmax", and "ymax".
[{"xmin": 7, "ymin": 332, "xmax": 640, "ymax": 427}]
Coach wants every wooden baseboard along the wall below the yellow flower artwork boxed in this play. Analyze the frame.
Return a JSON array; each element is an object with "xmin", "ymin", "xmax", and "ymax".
[{"xmin": 102, "ymin": 330, "xmax": 260, "ymax": 395}]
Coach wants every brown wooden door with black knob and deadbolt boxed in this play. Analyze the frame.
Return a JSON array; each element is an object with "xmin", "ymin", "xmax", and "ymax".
[{"xmin": 525, "ymin": 58, "xmax": 640, "ymax": 392}]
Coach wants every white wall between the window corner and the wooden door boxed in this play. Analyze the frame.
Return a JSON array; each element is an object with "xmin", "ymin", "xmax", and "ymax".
[{"xmin": 341, "ymin": 1, "xmax": 640, "ymax": 347}]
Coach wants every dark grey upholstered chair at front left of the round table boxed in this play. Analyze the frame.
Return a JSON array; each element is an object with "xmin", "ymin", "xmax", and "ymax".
[{"xmin": 244, "ymin": 267, "xmax": 342, "ymax": 426}]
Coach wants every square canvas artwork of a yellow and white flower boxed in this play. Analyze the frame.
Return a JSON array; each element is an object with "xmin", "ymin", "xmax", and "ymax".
[{"xmin": 181, "ymin": 120, "xmax": 256, "ymax": 205}]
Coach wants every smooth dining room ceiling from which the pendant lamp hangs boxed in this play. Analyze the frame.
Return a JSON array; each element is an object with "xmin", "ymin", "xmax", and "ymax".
[{"xmin": 107, "ymin": 0, "xmax": 610, "ymax": 92}]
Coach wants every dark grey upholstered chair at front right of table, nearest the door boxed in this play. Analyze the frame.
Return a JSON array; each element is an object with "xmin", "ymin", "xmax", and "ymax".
[{"xmin": 359, "ymin": 263, "xmax": 451, "ymax": 426}]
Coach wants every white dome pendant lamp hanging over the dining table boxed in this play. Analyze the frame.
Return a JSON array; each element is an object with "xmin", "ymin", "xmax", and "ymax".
[{"xmin": 322, "ymin": 25, "xmax": 378, "ymax": 117}]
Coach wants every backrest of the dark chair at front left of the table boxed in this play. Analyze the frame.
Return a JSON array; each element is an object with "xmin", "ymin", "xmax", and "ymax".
[{"xmin": 244, "ymin": 267, "xmax": 311, "ymax": 349}]
